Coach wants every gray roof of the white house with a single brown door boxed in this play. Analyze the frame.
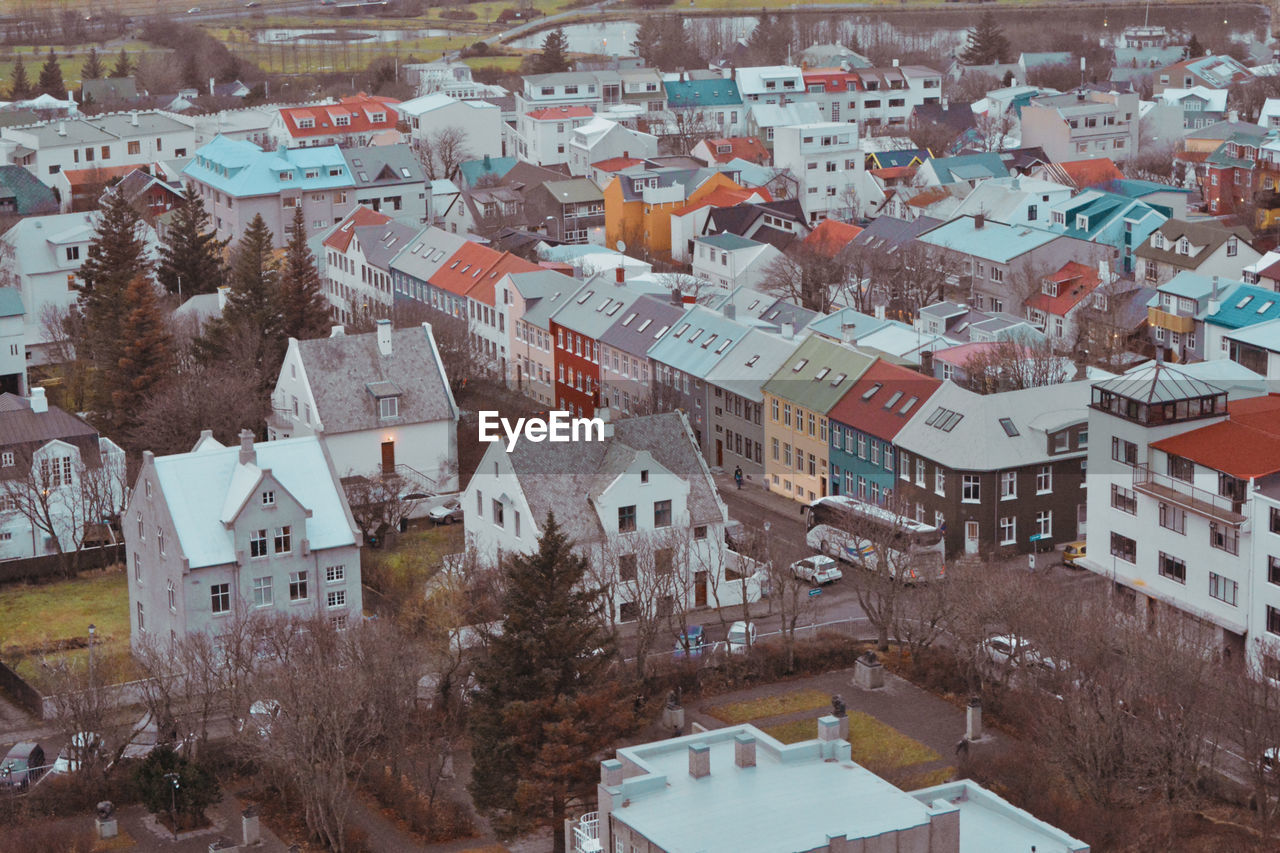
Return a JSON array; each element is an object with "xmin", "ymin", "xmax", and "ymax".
[{"xmin": 297, "ymin": 324, "xmax": 457, "ymax": 435}]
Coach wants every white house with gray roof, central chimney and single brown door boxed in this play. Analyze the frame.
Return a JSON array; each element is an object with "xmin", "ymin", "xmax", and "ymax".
[{"xmin": 268, "ymin": 320, "xmax": 460, "ymax": 494}]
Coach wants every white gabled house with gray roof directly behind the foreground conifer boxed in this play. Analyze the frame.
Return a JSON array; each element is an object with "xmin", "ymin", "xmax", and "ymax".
[{"xmin": 462, "ymin": 410, "xmax": 759, "ymax": 622}]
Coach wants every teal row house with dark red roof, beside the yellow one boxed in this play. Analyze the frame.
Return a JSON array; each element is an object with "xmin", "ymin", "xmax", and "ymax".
[{"xmin": 828, "ymin": 359, "xmax": 942, "ymax": 507}]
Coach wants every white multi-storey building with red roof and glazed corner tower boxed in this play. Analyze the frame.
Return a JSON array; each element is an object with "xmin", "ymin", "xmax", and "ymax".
[{"xmin": 1082, "ymin": 364, "xmax": 1280, "ymax": 678}]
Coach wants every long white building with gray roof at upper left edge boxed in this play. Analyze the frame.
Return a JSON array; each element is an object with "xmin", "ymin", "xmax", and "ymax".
[{"xmin": 0, "ymin": 110, "xmax": 196, "ymax": 187}]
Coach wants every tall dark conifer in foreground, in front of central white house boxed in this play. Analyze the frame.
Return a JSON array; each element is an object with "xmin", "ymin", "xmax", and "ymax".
[{"xmin": 470, "ymin": 514, "xmax": 635, "ymax": 852}]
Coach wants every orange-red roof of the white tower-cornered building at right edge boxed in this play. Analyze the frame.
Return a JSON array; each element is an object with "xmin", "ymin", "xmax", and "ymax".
[{"xmin": 1152, "ymin": 394, "xmax": 1280, "ymax": 479}]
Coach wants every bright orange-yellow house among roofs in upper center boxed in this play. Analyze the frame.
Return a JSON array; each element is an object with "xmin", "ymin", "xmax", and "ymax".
[{"xmin": 604, "ymin": 169, "xmax": 744, "ymax": 257}]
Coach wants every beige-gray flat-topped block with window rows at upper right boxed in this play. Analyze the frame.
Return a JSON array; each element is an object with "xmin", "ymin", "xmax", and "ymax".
[{"xmin": 1021, "ymin": 88, "xmax": 1139, "ymax": 161}]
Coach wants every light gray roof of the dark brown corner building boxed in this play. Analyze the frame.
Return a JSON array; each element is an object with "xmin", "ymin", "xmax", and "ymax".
[{"xmin": 895, "ymin": 382, "xmax": 1091, "ymax": 471}]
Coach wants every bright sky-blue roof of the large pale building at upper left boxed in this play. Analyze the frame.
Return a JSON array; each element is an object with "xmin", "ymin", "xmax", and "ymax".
[{"xmin": 182, "ymin": 136, "xmax": 355, "ymax": 197}]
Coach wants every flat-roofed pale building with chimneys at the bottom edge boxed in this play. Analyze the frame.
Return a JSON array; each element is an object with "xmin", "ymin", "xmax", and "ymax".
[{"xmin": 566, "ymin": 716, "xmax": 1089, "ymax": 853}]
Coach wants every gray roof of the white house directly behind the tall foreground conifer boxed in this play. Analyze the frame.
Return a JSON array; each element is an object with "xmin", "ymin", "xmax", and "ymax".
[{"xmin": 495, "ymin": 412, "xmax": 726, "ymax": 542}]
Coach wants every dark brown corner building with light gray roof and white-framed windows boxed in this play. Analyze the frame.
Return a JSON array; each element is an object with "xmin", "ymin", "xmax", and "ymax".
[{"xmin": 893, "ymin": 382, "xmax": 1089, "ymax": 553}]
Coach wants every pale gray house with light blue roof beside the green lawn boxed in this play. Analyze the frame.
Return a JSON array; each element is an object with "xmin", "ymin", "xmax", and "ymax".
[{"xmin": 122, "ymin": 429, "xmax": 364, "ymax": 654}]
